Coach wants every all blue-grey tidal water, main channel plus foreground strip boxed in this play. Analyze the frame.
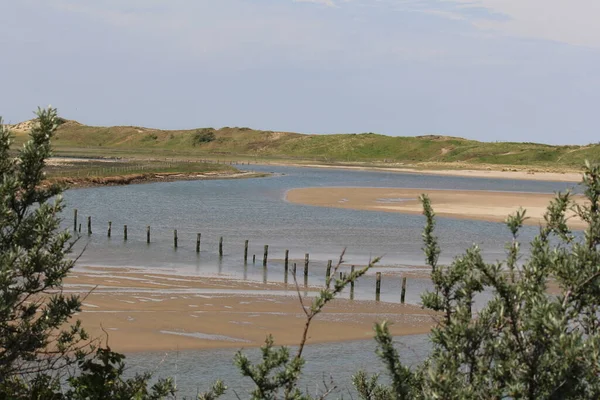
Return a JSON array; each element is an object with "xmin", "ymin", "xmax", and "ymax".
[{"xmin": 63, "ymin": 165, "xmax": 577, "ymax": 399}]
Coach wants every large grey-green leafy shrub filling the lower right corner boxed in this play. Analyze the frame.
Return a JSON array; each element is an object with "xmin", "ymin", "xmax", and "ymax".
[{"xmin": 354, "ymin": 164, "xmax": 600, "ymax": 400}]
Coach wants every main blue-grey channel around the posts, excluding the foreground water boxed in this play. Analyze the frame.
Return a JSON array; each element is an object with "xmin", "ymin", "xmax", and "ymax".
[{"xmin": 65, "ymin": 162, "xmax": 574, "ymax": 272}]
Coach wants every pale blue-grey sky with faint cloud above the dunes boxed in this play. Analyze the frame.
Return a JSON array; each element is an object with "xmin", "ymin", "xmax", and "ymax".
[{"xmin": 0, "ymin": 0, "xmax": 600, "ymax": 144}]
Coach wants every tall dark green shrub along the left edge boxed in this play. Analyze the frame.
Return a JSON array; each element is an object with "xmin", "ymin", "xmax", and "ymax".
[{"xmin": 0, "ymin": 108, "xmax": 174, "ymax": 400}]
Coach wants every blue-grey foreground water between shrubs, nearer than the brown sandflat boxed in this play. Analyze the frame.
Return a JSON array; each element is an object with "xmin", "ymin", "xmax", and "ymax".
[{"xmin": 127, "ymin": 335, "xmax": 429, "ymax": 399}]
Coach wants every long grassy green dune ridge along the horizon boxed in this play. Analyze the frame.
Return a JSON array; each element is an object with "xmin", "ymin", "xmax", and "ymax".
[{"xmin": 9, "ymin": 121, "xmax": 600, "ymax": 168}]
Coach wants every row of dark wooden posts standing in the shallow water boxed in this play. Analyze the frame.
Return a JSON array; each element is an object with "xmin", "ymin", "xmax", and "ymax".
[{"xmin": 73, "ymin": 209, "xmax": 406, "ymax": 304}]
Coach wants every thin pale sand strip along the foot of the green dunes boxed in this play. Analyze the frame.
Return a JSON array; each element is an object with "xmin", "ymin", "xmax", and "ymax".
[{"xmin": 259, "ymin": 161, "xmax": 582, "ymax": 183}]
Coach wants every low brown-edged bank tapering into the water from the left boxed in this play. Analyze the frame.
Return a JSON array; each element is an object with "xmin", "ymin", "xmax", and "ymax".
[{"xmin": 44, "ymin": 171, "xmax": 271, "ymax": 189}]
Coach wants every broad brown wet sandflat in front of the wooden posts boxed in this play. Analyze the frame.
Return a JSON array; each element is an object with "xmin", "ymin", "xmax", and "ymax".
[{"xmin": 65, "ymin": 267, "xmax": 434, "ymax": 352}]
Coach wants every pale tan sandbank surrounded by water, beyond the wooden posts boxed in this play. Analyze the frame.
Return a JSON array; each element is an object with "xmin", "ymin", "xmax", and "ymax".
[{"xmin": 286, "ymin": 187, "xmax": 585, "ymax": 229}]
